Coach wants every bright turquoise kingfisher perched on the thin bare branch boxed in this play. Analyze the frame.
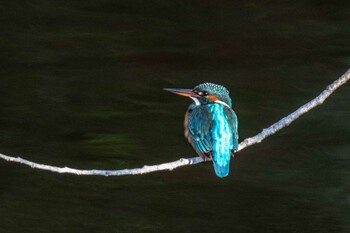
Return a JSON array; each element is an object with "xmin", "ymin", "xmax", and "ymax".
[{"xmin": 164, "ymin": 83, "xmax": 238, "ymax": 178}]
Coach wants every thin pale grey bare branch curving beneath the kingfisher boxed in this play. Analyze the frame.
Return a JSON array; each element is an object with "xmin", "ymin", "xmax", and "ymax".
[{"xmin": 0, "ymin": 69, "xmax": 350, "ymax": 176}]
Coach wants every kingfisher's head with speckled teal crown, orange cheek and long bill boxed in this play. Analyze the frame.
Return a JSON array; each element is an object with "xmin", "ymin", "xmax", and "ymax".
[{"xmin": 164, "ymin": 83, "xmax": 232, "ymax": 108}]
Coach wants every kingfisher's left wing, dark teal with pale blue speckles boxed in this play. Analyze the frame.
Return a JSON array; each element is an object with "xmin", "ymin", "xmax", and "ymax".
[{"xmin": 185, "ymin": 106, "xmax": 212, "ymax": 156}]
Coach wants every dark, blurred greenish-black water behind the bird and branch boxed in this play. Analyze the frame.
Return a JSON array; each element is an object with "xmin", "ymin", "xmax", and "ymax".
[{"xmin": 0, "ymin": 0, "xmax": 350, "ymax": 233}]
